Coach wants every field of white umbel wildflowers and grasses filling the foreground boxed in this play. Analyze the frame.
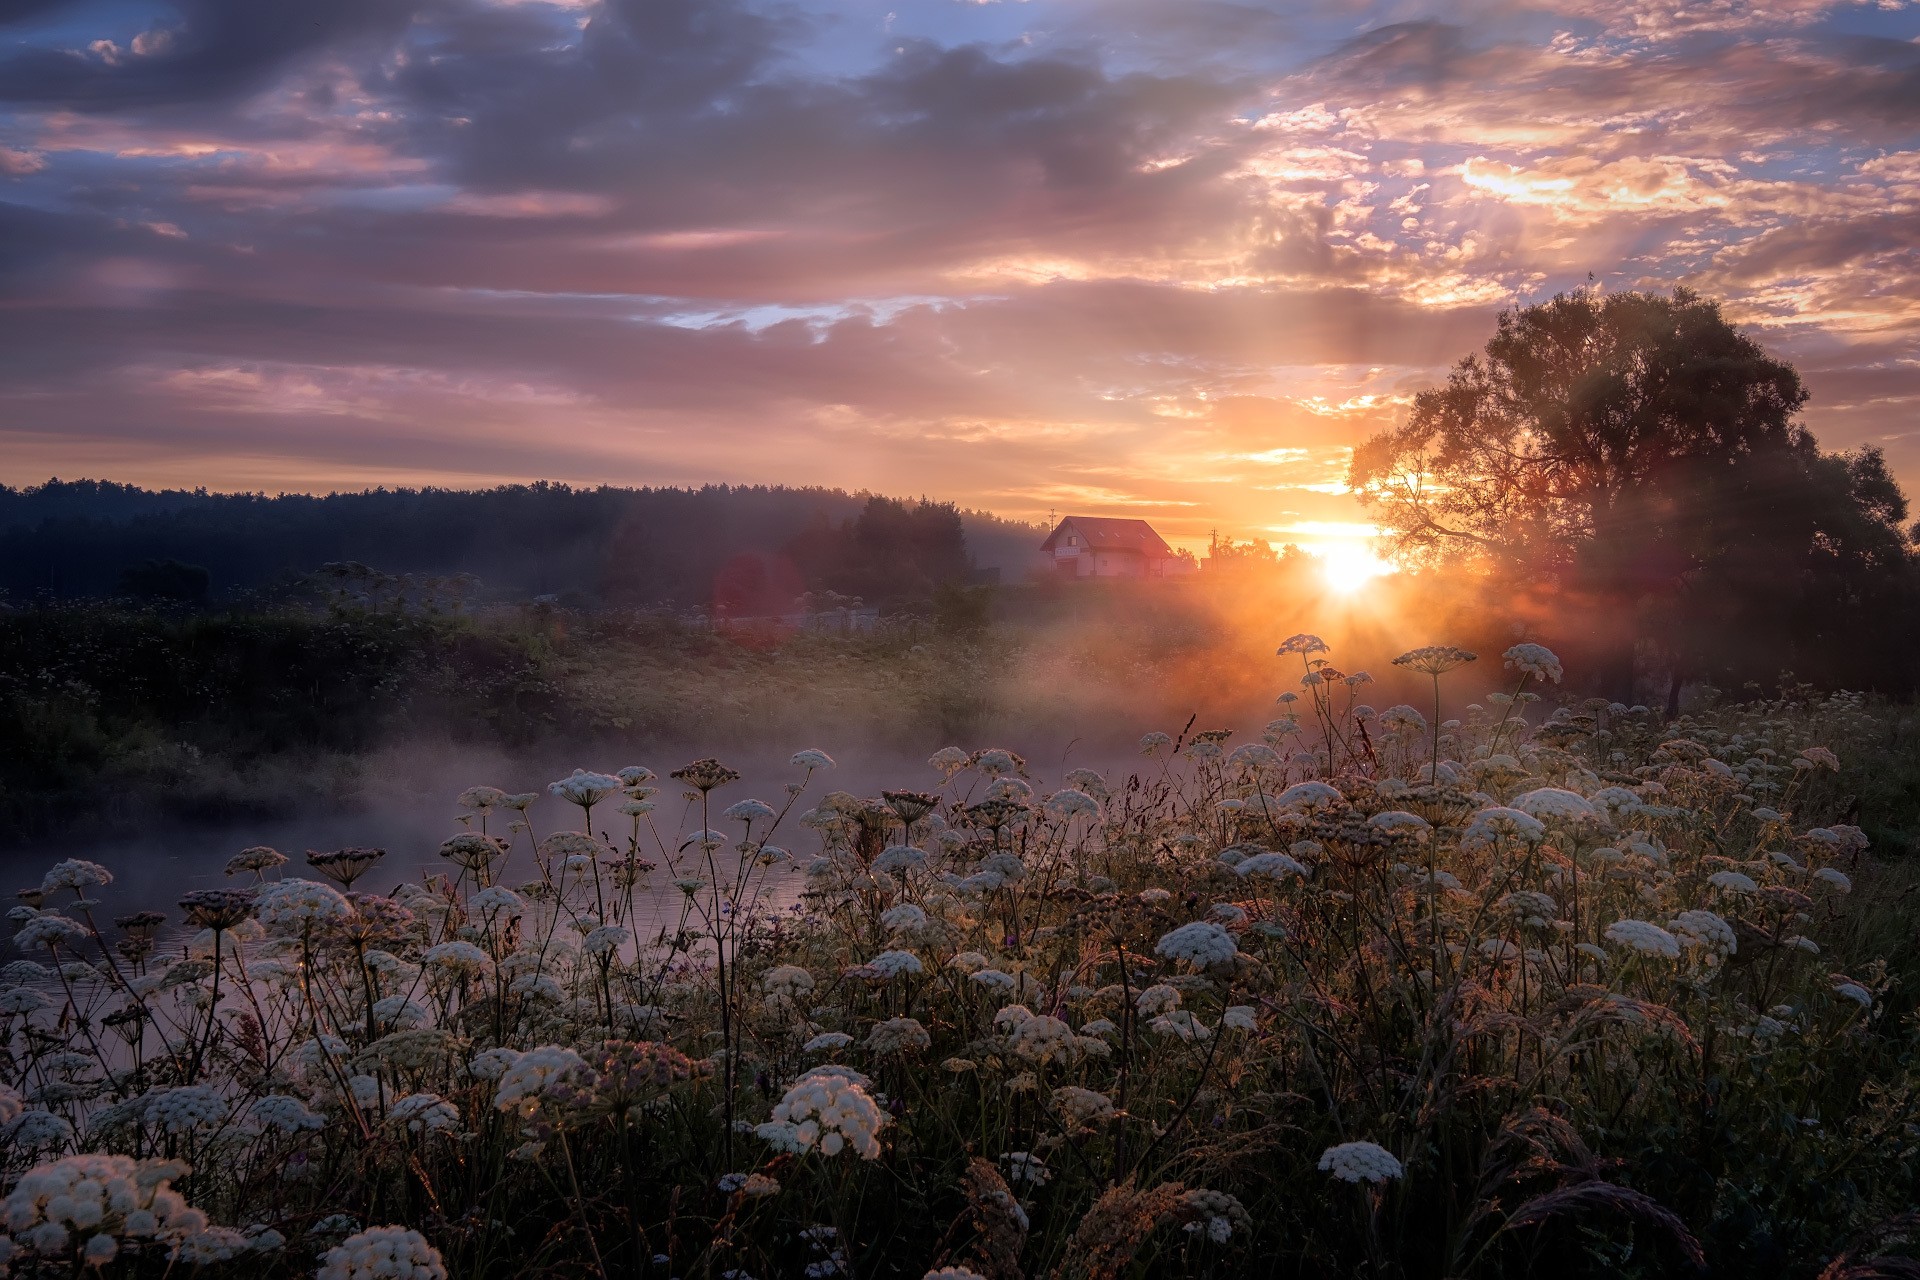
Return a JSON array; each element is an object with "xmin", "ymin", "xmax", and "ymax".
[{"xmin": 0, "ymin": 635, "xmax": 1920, "ymax": 1280}]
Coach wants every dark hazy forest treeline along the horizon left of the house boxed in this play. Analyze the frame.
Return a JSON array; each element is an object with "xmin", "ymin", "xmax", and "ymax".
[{"xmin": 0, "ymin": 480, "xmax": 1044, "ymax": 612}]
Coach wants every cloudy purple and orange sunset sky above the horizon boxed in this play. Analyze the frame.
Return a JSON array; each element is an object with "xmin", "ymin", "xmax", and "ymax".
[{"xmin": 0, "ymin": 0, "xmax": 1920, "ymax": 547}]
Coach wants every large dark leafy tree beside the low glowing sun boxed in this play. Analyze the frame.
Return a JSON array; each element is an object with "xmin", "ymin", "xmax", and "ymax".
[{"xmin": 1350, "ymin": 288, "xmax": 1916, "ymax": 693}]
